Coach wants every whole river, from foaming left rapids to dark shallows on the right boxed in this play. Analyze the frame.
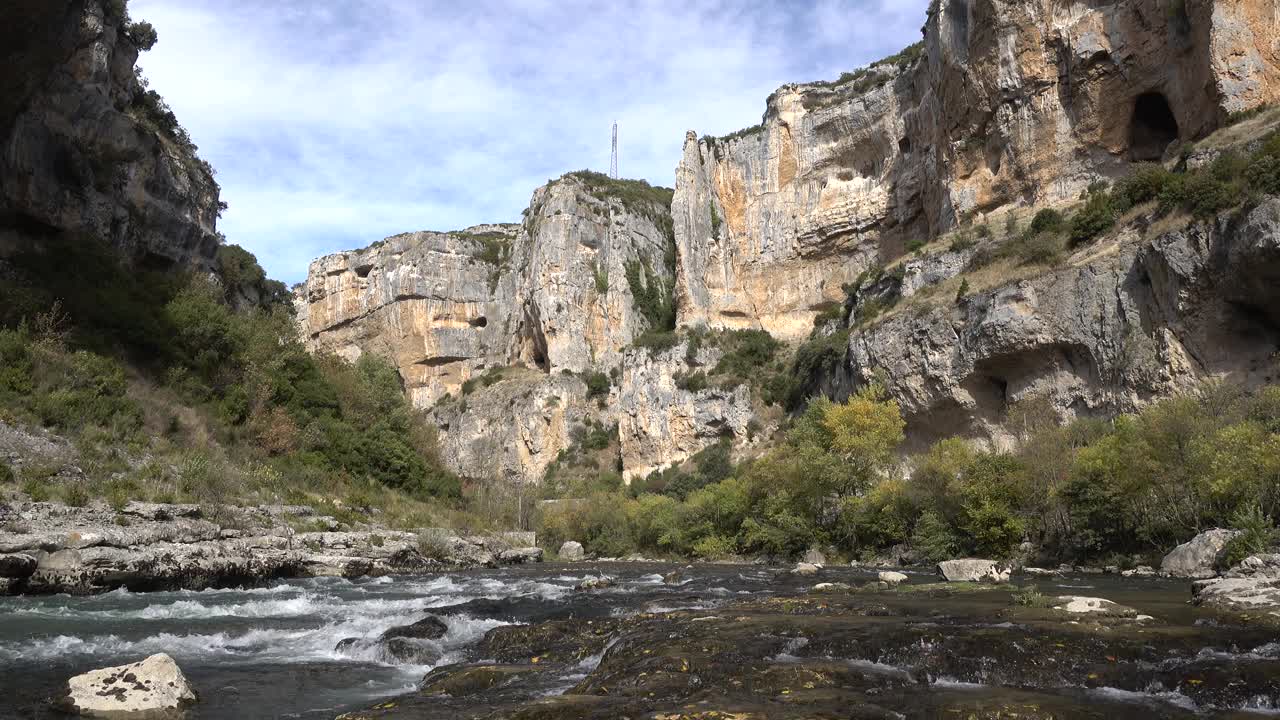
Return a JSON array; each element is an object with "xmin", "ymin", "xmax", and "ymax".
[{"xmin": 0, "ymin": 564, "xmax": 1280, "ymax": 720}]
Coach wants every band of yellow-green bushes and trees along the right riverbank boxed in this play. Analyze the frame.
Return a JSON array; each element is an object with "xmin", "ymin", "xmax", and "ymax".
[{"xmin": 541, "ymin": 384, "xmax": 1280, "ymax": 565}]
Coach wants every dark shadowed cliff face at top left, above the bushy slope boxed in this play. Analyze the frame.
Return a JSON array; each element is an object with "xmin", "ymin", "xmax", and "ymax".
[{"xmin": 0, "ymin": 0, "xmax": 219, "ymax": 268}]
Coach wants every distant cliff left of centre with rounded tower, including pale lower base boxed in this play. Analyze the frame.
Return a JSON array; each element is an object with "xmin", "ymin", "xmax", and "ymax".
[{"xmin": 296, "ymin": 173, "xmax": 691, "ymax": 483}]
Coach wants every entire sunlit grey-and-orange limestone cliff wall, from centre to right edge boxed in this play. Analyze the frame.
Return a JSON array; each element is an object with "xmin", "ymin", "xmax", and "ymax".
[{"xmin": 298, "ymin": 0, "xmax": 1280, "ymax": 483}]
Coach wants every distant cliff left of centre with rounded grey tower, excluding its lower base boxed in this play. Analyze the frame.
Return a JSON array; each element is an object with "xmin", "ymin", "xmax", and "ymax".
[{"xmin": 296, "ymin": 173, "xmax": 673, "ymax": 409}]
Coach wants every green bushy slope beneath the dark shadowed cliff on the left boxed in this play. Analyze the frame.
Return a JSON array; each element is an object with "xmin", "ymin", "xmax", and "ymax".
[{"xmin": 0, "ymin": 229, "xmax": 496, "ymax": 525}]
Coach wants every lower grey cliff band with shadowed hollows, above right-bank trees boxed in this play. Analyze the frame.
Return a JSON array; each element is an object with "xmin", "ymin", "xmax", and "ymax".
[{"xmin": 817, "ymin": 200, "xmax": 1280, "ymax": 446}]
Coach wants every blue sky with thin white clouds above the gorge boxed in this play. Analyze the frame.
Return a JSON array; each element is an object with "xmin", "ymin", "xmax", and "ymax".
[{"xmin": 129, "ymin": 0, "xmax": 928, "ymax": 284}]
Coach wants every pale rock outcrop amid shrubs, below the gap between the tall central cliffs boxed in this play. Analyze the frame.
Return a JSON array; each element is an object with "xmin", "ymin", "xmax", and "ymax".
[{"xmin": 614, "ymin": 340, "xmax": 753, "ymax": 480}]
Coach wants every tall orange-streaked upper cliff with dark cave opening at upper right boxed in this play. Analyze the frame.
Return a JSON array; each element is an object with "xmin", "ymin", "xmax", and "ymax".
[{"xmin": 672, "ymin": 0, "xmax": 1280, "ymax": 337}]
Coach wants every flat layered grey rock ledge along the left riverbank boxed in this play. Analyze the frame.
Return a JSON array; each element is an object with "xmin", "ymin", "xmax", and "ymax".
[{"xmin": 0, "ymin": 502, "xmax": 541, "ymax": 594}]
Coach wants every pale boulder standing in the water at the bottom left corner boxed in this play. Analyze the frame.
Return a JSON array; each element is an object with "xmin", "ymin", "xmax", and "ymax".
[{"xmin": 59, "ymin": 653, "xmax": 196, "ymax": 717}]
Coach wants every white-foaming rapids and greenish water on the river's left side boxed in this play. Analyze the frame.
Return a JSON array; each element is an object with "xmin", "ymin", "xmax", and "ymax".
[{"xmin": 0, "ymin": 566, "xmax": 768, "ymax": 720}]
